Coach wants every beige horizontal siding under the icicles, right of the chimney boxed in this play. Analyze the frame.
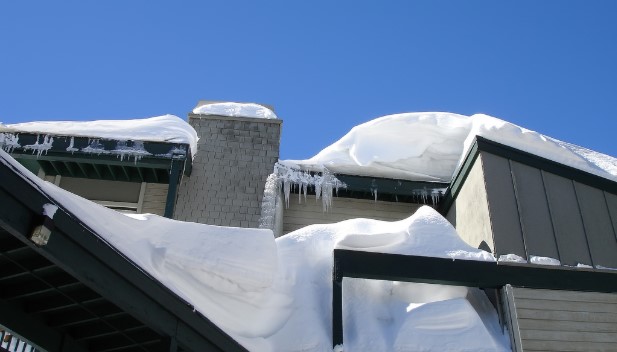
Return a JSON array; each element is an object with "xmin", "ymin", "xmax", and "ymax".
[{"xmin": 283, "ymin": 194, "xmax": 420, "ymax": 234}]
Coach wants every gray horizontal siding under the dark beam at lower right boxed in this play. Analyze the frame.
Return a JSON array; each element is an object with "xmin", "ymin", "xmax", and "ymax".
[{"xmin": 513, "ymin": 287, "xmax": 617, "ymax": 351}]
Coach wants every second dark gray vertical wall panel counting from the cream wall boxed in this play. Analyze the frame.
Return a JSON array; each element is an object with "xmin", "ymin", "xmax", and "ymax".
[{"xmin": 511, "ymin": 161, "xmax": 559, "ymax": 258}]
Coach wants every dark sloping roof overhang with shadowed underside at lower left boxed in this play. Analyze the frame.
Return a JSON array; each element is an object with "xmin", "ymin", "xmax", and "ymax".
[{"xmin": 0, "ymin": 155, "xmax": 246, "ymax": 352}]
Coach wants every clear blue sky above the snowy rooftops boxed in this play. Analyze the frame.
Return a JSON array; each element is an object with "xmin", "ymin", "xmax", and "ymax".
[{"xmin": 0, "ymin": 0, "xmax": 617, "ymax": 159}]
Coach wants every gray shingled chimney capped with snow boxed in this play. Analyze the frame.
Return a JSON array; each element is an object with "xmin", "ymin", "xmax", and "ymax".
[{"xmin": 174, "ymin": 100, "xmax": 282, "ymax": 228}]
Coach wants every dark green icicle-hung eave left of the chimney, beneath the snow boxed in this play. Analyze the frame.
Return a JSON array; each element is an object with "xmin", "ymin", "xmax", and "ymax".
[{"xmin": 0, "ymin": 132, "xmax": 192, "ymax": 184}]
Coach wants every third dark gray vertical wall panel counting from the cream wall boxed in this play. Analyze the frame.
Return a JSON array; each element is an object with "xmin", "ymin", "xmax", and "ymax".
[{"xmin": 542, "ymin": 172, "xmax": 593, "ymax": 266}]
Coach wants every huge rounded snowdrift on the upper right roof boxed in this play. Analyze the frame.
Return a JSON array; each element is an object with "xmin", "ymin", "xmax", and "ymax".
[{"xmin": 281, "ymin": 112, "xmax": 617, "ymax": 182}]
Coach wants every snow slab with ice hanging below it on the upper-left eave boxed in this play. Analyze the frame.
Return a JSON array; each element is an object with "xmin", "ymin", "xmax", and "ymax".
[{"xmin": 0, "ymin": 115, "xmax": 198, "ymax": 157}]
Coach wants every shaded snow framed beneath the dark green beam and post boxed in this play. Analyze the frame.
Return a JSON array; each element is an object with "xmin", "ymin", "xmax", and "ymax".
[{"xmin": 343, "ymin": 279, "xmax": 508, "ymax": 352}]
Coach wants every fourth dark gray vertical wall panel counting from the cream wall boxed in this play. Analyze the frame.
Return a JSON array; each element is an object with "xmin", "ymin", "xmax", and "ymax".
[{"xmin": 574, "ymin": 182, "xmax": 617, "ymax": 268}]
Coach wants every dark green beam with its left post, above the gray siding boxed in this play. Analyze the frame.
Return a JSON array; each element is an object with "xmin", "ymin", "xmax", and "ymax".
[{"xmin": 332, "ymin": 249, "xmax": 617, "ymax": 346}]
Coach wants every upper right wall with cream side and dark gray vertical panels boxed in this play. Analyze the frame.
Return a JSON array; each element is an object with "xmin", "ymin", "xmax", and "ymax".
[{"xmin": 445, "ymin": 151, "xmax": 617, "ymax": 268}]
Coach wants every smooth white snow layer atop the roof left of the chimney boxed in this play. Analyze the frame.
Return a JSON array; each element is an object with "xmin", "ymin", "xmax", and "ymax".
[{"xmin": 3, "ymin": 115, "xmax": 198, "ymax": 156}]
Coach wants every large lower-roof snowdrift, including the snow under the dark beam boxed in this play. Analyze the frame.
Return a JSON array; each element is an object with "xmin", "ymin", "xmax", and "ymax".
[{"xmin": 0, "ymin": 151, "xmax": 509, "ymax": 352}]
